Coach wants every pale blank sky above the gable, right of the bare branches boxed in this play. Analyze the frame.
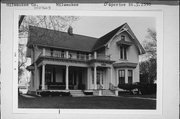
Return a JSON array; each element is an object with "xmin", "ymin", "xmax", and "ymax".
[{"xmin": 72, "ymin": 16, "xmax": 155, "ymax": 42}]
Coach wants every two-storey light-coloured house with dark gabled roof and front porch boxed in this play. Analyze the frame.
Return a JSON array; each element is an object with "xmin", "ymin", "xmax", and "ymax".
[{"xmin": 27, "ymin": 23, "xmax": 145, "ymax": 96}]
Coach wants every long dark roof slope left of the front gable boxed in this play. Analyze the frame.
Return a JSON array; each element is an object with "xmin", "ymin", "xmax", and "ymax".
[{"xmin": 27, "ymin": 26, "xmax": 97, "ymax": 52}]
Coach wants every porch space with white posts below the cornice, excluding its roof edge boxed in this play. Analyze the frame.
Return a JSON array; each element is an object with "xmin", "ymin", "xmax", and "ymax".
[{"xmin": 34, "ymin": 62, "xmax": 115, "ymax": 91}]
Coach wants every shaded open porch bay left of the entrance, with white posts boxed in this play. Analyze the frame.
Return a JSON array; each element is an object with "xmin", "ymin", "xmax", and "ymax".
[{"xmin": 39, "ymin": 64, "xmax": 87, "ymax": 90}]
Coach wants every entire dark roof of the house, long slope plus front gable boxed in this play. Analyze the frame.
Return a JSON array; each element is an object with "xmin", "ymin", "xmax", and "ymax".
[{"xmin": 27, "ymin": 23, "xmax": 145, "ymax": 54}]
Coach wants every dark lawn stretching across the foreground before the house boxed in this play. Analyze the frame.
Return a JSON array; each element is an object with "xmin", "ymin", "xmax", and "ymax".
[{"xmin": 19, "ymin": 96, "xmax": 156, "ymax": 109}]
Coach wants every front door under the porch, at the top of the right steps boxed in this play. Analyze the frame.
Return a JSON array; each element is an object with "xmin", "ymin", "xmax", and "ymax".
[{"xmin": 97, "ymin": 70, "xmax": 104, "ymax": 89}]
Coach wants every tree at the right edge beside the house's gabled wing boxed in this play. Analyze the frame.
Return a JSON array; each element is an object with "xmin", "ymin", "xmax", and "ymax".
[{"xmin": 140, "ymin": 29, "xmax": 157, "ymax": 83}]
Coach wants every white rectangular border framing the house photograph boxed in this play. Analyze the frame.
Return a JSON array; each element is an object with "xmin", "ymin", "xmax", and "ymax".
[{"xmin": 13, "ymin": 10, "xmax": 164, "ymax": 116}]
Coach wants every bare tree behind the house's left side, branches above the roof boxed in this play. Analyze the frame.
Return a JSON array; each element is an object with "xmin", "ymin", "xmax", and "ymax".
[{"xmin": 18, "ymin": 15, "xmax": 79, "ymax": 80}]
